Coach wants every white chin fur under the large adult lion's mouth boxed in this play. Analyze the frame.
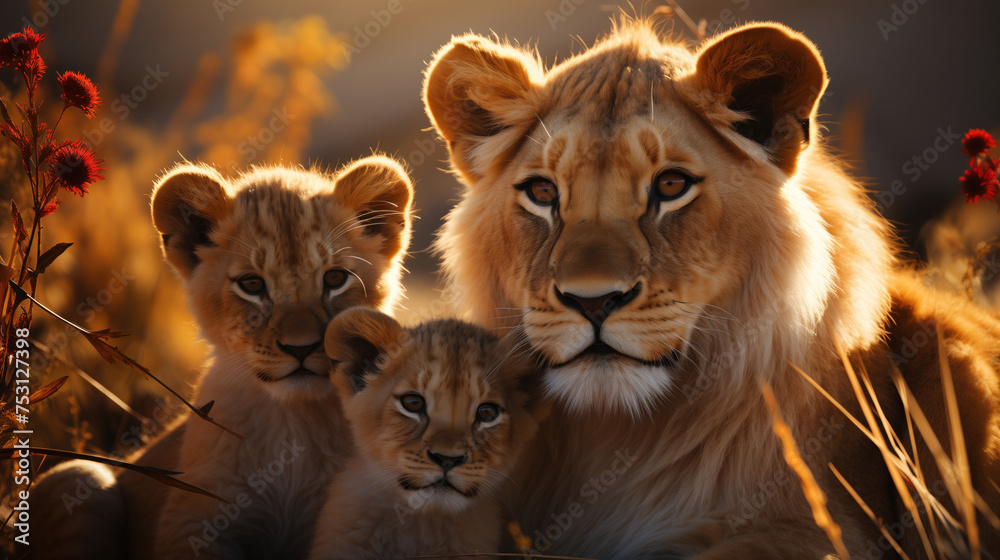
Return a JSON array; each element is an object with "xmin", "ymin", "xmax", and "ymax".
[{"xmin": 542, "ymin": 359, "xmax": 673, "ymax": 416}]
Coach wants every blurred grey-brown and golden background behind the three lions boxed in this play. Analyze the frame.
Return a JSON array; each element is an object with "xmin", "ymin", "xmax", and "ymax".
[{"xmin": 0, "ymin": 0, "xmax": 1000, "ymax": 544}]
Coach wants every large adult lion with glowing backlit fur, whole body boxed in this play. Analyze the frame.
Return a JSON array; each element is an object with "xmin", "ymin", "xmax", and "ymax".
[{"xmin": 424, "ymin": 21, "xmax": 1000, "ymax": 560}]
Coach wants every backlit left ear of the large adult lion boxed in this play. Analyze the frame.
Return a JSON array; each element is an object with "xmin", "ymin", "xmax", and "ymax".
[{"xmin": 424, "ymin": 34, "xmax": 543, "ymax": 179}]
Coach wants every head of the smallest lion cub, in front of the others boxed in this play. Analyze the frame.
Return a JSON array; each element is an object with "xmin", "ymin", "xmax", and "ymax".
[{"xmin": 326, "ymin": 308, "xmax": 536, "ymax": 511}]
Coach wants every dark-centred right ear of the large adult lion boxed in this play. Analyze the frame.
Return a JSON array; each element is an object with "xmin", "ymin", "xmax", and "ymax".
[{"xmin": 680, "ymin": 23, "xmax": 827, "ymax": 175}]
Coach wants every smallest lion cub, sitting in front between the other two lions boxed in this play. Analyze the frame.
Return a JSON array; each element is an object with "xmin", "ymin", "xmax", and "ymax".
[{"xmin": 309, "ymin": 308, "xmax": 541, "ymax": 560}]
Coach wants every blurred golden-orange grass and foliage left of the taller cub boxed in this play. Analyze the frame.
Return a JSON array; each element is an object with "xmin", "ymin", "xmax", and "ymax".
[{"xmin": 0, "ymin": 10, "xmax": 347, "ymax": 554}]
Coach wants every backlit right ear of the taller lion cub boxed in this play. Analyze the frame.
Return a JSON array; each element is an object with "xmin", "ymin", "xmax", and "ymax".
[{"xmin": 333, "ymin": 156, "xmax": 413, "ymax": 259}]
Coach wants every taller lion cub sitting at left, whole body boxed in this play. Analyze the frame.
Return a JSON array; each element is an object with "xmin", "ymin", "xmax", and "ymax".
[{"xmin": 32, "ymin": 156, "xmax": 413, "ymax": 558}]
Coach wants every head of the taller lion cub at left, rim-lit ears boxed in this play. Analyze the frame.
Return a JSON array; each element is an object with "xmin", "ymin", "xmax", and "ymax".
[{"xmin": 153, "ymin": 158, "xmax": 412, "ymax": 397}]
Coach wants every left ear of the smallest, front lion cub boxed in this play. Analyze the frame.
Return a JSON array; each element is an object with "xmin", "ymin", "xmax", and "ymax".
[{"xmin": 323, "ymin": 307, "xmax": 403, "ymax": 396}]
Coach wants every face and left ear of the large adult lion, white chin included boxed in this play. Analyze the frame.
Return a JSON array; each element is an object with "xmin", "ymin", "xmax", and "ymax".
[{"xmin": 425, "ymin": 24, "xmax": 822, "ymax": 412}]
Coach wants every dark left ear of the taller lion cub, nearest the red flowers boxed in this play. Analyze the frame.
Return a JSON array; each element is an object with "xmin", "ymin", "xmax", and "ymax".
[{"xmin": 152, "ymin": 164, "xmax": 230, "ymax": 279}]
